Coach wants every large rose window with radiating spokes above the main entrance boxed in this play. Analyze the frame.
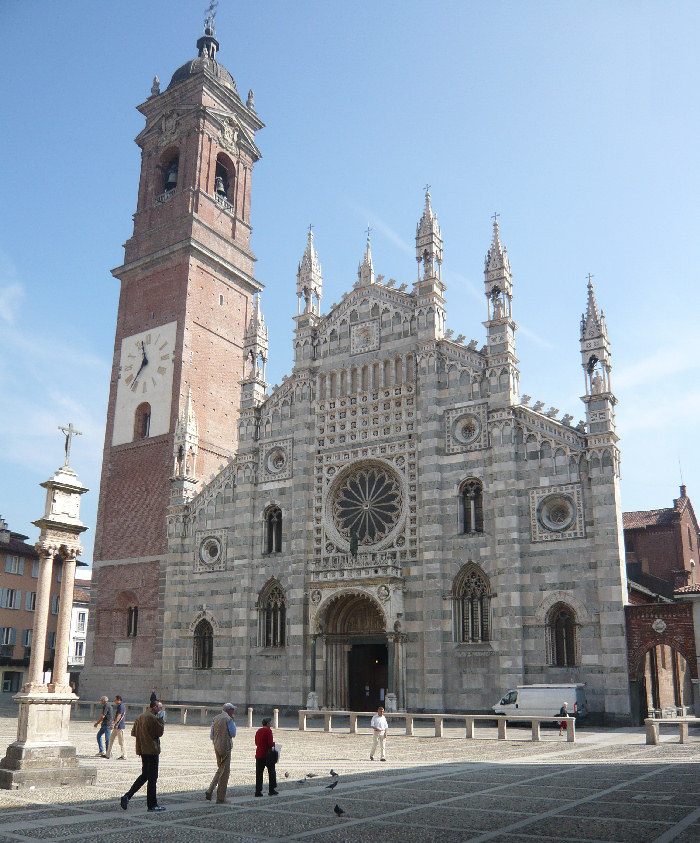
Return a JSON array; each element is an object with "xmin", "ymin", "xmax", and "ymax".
[{"xmin": 329, "ymin": 462, "xmax": 403, "ymax": 545}]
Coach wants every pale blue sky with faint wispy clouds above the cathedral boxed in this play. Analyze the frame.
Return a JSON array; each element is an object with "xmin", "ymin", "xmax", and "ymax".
[{"xmin": 0, "ymin": 0, "xmax": 700, "ymax": 562}]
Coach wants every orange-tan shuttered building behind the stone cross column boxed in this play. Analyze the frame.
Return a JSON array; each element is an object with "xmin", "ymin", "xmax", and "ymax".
[{"xmin": 0, "ymin": 519, "xmax": 61, "ymax": 695}]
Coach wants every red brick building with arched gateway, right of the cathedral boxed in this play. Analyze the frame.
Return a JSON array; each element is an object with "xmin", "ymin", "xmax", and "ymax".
[{"xmin": 622, "ymin": 486, "xmax": 700, "ymax": 722}]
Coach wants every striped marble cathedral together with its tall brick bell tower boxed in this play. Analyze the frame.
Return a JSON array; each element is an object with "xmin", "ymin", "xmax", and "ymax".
[{"xmin": 83, "ymin": 23, "xmax": 629, "ymax": 722}]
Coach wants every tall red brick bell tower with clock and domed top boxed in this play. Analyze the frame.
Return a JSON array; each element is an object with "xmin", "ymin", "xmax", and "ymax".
[{"xmin": 81, "ymin": 13, "xmax": 264, "ymax": 699}]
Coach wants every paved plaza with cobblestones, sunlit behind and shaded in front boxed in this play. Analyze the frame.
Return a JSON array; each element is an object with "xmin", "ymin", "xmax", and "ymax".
[{"xmin": 0, "ymin": 713, "xmax": 700, "ymax": 843}]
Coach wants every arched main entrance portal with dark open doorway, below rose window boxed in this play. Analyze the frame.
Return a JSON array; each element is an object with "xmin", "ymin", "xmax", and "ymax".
[{"xmin": 323, "ymin": 594, "xmax": 393, "ymax": 711}]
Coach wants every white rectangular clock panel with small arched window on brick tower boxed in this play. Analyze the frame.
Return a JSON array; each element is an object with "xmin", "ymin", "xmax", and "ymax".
[{"xmin": 112, "ymin": 322, "xmax": 177, "ymax": 445}]
